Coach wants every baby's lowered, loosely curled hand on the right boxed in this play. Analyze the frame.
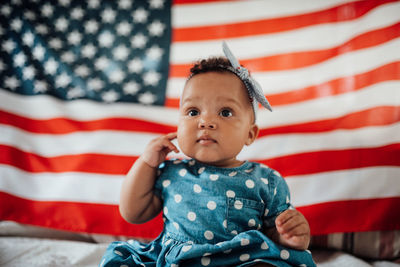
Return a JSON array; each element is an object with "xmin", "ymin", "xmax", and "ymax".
[{"xmin": 275, "ymin": 210, "xmax": 310, "ymax": 250}]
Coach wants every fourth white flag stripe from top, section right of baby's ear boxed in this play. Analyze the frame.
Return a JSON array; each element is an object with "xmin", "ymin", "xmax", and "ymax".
[{"xmin": 257, "ymin": 81, "xmax": 400, "ymax": 128}]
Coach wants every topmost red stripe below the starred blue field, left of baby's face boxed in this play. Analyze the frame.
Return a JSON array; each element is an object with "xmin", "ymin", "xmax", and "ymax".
[{"xmin": 0, "ymin": 110, "xmax": 176, "ymax": 134}]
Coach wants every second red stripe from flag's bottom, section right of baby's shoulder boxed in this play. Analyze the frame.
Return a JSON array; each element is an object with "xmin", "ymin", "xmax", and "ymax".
[{"xmin": 259, "ymin": 144, "xmax": 400, "ymax": 177}]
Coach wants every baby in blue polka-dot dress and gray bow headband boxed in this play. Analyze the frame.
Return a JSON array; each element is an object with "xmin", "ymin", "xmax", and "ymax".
[{"xmin": 100, "ymin": 43, "xmax": 315, "ymax": 266}]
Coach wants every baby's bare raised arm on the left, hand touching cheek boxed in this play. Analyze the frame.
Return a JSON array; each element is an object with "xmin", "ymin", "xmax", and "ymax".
[{"xmin": 119, "ymin": 133, "xmax": 178, "ymax": 223}]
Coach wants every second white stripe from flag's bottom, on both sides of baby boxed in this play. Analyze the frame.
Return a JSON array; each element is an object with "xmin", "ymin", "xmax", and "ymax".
[{"xmin": 0, "ymin": 123, "xmax": 400, "ymax": 159}]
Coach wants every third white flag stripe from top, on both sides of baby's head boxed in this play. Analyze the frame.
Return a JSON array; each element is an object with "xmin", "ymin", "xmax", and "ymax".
[{"xmin": 167, "ymin": 38, "xmax": 400, "ymax": 98}]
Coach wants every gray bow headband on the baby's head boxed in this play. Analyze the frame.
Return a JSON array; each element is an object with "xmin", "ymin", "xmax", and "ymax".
[{"xmin": 222, "ymin": 42, "xmax": 272, "ymax": 116}]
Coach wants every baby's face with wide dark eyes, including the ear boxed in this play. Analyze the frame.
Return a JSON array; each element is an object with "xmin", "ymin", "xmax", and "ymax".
[{"xmin": 178, "ymin": 72, "xmax": 258, "ymax": 167}]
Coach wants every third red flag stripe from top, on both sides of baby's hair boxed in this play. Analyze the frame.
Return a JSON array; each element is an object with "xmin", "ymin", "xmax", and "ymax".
[{"xmin": 169, "ymin": 23, "xmax": 400, "ymax": 77}]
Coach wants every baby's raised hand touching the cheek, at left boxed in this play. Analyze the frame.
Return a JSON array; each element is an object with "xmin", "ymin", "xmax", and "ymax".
[{"xmin": 140, "ymin": 132, "xmax": 179, "ymax": 168}]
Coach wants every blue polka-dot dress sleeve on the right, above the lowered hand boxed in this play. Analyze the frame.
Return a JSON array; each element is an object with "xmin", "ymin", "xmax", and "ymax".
[{"xmin": 263, "ymin": 170, "xmax": 292, "ymax": 228}]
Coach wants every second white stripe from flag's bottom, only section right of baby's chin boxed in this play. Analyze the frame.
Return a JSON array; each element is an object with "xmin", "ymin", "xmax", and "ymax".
[{"xmin": 238, "ymin": 123, "xmax": 400, "ymax": 161}]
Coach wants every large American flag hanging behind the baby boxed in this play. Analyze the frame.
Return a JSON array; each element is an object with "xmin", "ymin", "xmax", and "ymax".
[{"xmin": 0, "ymin": 0, "xmax": 400, "ymax": 241}]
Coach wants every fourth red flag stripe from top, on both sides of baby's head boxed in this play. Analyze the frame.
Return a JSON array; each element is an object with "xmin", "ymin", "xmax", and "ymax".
[{"xmin": 165, "ymin": 61, "xmax": 400, "ymax": 108}]
